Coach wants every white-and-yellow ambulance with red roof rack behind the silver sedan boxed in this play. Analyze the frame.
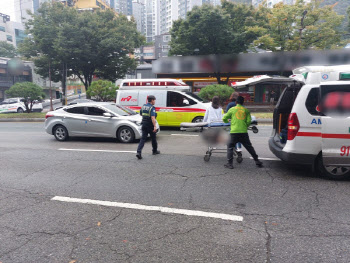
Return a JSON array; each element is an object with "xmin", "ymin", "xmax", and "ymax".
[{"xmin": 116, "ymin": 79, "xmax": 210, "ymax": 127}]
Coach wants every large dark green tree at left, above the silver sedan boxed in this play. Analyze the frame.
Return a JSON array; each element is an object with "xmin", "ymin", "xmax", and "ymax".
[{"xmin": 21, "ymin": 3, "xmax": 144, "ymax": 104}]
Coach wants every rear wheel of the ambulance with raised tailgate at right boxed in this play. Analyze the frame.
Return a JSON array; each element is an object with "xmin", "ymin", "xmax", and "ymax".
[{"xmin": 316, "ymin": 154, "xmax": 350, "ymax": 180}]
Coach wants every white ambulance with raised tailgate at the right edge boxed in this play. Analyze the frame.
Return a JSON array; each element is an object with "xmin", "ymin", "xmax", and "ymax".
[{"xmin": 237, "ymin": 65, "xmax": 350, "ymax": 182}]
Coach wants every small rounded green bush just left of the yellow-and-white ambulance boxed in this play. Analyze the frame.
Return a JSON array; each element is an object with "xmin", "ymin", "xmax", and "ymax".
[{"xmin": 87, "ymin": 80, "xmax": 118, "ymax": 101}]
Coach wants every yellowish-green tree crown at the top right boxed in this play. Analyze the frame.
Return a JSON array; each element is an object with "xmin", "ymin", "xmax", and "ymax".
[{"xmin": 248, "ymin": 0, "xmax": 344, "ymax": 51}]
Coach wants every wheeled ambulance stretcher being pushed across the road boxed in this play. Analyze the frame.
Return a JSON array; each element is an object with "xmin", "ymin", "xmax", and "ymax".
[{"xmin": 180, "ymin": 119, "xmax": 259, "ymax": 163}]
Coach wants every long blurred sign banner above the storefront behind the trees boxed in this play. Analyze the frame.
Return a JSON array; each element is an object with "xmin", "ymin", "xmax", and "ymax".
[{"xmin": 152, "ymin": 49, "xmax": 350, "ymax": 74}]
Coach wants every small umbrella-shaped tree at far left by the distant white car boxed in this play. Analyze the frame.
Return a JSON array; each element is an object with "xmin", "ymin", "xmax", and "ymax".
[{"xmin": 6, "ymin": 82, "xmax": 45, "ymax": 113}]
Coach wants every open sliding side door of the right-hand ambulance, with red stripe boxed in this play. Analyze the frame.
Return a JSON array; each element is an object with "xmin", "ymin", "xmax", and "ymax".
[{"xmin": 321, "ymin": 85, "xmax": 350, "ymax": 167}]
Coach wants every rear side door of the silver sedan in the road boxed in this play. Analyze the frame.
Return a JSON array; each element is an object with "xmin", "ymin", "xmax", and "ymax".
[{"xmin": 63, "ymin": 106, "xmax": 88, "ymax": 136}]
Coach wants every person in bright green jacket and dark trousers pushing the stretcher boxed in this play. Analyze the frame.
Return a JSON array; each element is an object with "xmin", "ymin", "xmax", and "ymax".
[{"xmin": 223, "ymin": 96, "xmax": 262, "ymax": 169}]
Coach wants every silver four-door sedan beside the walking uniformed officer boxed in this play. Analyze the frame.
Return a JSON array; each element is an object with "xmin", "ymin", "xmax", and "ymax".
[{"xmin": 45, "ymin": 102, "xmax": 159, "ymax": 143}]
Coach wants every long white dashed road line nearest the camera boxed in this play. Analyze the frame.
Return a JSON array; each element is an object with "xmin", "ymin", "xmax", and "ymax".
[{"xmin": 51, "ymin": 196, "xmax": 243, "ymax": 221}]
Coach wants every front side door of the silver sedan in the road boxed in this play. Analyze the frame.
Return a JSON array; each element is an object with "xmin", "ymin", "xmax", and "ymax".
[{"xmin": 86, "ymin": 106, "xmax": 116, "ymax": 137}]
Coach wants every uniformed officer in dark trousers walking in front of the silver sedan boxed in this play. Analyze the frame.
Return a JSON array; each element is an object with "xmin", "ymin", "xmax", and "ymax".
[{"xmin": 136, "ymin": 95, "xmax": 160, "ymax": 159}]
